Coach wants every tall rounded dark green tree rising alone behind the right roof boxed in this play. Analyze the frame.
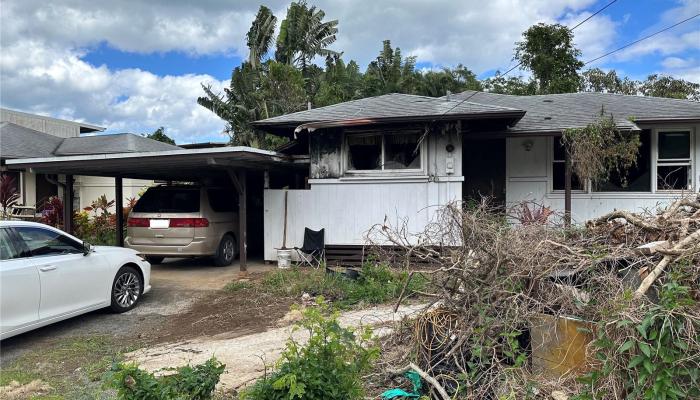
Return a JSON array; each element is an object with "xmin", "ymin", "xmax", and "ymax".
[{"xmin": 514, "ymin": 23, "xmax": 583, "ymax": 94}]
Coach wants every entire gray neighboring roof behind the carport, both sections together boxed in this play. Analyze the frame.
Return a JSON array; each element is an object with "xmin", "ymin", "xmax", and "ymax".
[{"xmin": 0, "ymin": 122, "xmax": 181, "ymax": 159}]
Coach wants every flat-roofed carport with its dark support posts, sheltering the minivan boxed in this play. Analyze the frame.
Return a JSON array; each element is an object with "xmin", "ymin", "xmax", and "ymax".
[{"xmin": 6, "ymin": 147, "xmax": 308, "ymax": 272}]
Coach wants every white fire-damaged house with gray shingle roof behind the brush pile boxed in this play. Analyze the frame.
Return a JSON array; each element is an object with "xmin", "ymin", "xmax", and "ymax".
[{"xmin": 255, "ymin": 91, "xmax": 700, "ymax": 260}]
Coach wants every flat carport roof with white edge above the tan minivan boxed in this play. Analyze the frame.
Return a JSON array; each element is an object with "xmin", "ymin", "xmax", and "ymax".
[{"xmin": 6, "ymin": 146, "xmax": 308, "ymax": 181}]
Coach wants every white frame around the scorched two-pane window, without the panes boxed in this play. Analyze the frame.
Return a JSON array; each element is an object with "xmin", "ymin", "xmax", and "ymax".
[{"xmin": 342, "ymin": 130, "xmax": 426, "ymax": 175}]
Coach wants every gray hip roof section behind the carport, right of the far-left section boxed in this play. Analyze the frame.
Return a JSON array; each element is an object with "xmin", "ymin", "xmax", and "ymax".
[{"xmin": 54, "ymin": 133, "xmax": 180, "ymax": 156}]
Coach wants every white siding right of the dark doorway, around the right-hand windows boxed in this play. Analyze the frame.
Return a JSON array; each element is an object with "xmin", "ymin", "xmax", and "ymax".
[{"xmin": 506, "ymin": 125, "xmax": 700, "ymax": 222}]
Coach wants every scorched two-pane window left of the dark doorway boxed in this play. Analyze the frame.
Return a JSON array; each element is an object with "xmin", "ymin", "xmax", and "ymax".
[{"xmin": 347, "ymin": 133, "xmax": 421, "ymax": 171}]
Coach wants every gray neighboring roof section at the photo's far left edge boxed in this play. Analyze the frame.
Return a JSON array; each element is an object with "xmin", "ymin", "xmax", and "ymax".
[{"xmin": 0, "ymin": 122, "xmax": 63, "ymax": 159}]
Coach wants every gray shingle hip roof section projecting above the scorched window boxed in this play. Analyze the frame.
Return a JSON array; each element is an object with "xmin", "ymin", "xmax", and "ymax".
[{"xmin": 254, "ymin": 93, "xmax": 522, "ymax": 127}]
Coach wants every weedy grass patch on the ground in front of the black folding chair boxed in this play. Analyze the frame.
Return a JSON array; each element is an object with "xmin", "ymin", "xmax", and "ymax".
[{"xmin": 226, "ymin": 263, "xmax": 427, "ymax": 309}]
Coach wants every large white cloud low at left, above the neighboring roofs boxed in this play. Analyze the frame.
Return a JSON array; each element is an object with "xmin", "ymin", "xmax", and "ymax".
[{"xmin": 0, "ymin": 42, "xmax": 227, "ymax": 143}]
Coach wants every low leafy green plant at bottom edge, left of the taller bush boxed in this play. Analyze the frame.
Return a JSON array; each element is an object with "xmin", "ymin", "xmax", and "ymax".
[{"xmin": 107, "ymin": 358, "xmax": 226, "ymax": 400}]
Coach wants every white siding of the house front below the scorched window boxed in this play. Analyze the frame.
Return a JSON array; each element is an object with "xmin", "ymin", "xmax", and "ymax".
[{"xmin": 264, "ymin": 130, "xmax": 464, "ymax": 260}]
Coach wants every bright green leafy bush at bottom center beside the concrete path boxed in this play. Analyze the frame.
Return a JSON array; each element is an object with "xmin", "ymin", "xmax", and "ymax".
[{"xmin": 240, "ymin": 298, "xmax": 379, "ymax": 400}]
